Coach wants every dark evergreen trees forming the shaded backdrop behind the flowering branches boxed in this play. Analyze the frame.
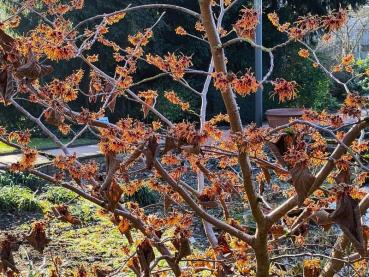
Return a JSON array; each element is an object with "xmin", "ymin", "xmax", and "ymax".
[{"xmin": 2, "ymin": 0, "xmax": 366, "ymax": 123}]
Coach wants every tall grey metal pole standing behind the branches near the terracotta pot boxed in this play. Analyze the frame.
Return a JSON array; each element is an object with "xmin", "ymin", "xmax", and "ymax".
[{"xmin": 254, "ymin": 0, "xmax": 263, "ymax": 127}]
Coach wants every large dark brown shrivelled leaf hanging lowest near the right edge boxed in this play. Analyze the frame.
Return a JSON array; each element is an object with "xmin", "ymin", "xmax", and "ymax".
[{"xmin": 330, "ymin": 191, "xmax": 366, "ymax": 255}]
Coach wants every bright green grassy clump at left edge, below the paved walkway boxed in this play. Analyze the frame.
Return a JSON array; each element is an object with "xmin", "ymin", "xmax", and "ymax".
[{"xmin": 0, "ymin": 186, "xmax": 41, "ymax": 212}]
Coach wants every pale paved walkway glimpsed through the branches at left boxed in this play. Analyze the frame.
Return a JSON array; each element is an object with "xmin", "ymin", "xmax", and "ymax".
[{"xmin": 0, "ymin": 144, "xmax": 101, "ymax": 165}]
